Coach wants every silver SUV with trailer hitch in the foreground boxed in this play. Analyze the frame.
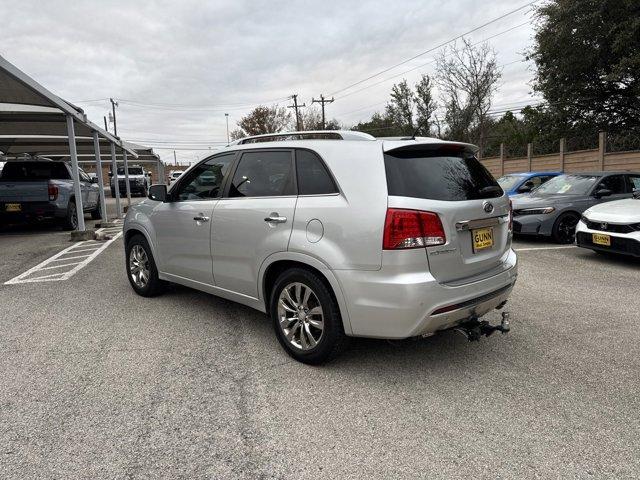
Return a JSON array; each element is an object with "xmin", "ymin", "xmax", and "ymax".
[{"xmin": 124, "ymin": 131, "xmax": 517, "ymax": 364}]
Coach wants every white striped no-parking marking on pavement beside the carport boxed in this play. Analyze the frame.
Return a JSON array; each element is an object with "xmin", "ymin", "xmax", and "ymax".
[{"xmin": 4, "ymin": 228, "xmax": 122, "ymax": 285}]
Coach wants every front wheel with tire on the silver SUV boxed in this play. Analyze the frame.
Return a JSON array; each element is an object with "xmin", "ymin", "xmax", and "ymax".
[{"xmin": 125, "ymin": 234, "xmax": 165, "ymax": 297}]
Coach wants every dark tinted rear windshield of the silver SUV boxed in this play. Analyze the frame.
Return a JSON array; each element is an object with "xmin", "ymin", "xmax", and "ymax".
[{"xmin": 384, "ymin": 149, "xmax": 503, "ymax": 201}]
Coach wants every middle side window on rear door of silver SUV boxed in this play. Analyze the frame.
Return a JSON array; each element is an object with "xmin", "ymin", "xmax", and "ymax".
[{"xmin": 229, "ymin": 151, "xmax": 295, "ymax": 197}]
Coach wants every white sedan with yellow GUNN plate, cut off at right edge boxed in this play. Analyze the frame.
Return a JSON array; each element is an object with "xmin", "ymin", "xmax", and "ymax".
[{"xmin": 576, "ymin": 192, "xmax": 640, "ymax": 257}]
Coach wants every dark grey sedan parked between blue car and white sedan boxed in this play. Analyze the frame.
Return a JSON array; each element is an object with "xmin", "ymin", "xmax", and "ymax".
[{"xmin": 511, "ymin": 172, "xmax": 640, "ymax": 243}]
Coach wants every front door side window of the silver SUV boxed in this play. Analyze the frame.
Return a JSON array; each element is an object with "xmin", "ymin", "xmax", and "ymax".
[{"xmin": 174, "ymin": 153, "xmax": 235, "ymax": 201}]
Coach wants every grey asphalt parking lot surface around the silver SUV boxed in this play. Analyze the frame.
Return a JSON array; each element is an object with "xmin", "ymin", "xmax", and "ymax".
[{"xmin": 0, "ymin": 217, "xmax": 640, "ymax": 479}]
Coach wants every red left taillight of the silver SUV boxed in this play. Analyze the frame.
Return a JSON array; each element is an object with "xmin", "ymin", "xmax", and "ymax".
[{"xmin": 382, "ymin": 208, "xmax": 447, "ymax": 250}]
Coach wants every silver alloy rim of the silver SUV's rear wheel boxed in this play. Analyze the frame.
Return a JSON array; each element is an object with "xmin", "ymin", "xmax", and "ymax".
[{"xmin": 278, "ymin": 282, "xmax": 324, "ymax": 350}]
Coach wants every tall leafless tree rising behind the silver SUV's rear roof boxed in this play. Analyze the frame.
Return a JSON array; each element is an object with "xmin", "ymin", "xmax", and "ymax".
[{"xmin": 436, "ymin": 38, "xmax": 501, "ymax": 147}]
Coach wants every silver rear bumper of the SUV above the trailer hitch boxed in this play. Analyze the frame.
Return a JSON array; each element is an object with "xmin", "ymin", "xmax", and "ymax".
[{"xmin": 334, "ymin": 250, "xmax": 518, "ymax": 338}]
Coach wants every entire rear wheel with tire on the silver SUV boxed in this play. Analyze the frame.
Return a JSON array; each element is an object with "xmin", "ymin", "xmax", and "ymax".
[{"xmin": 270, "ymin": 268, "xmax": 348, "ymax": 365}]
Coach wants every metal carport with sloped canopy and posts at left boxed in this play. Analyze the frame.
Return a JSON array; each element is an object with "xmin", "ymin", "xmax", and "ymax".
[{"xmin": 0, "ymin": 56, "xmax": 149, "ymax": 231}]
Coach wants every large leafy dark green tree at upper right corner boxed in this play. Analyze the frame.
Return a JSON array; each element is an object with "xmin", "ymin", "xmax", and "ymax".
[{"xmin": 528, "ymin": 0, "xmax": 640, "ymax": 136}]
